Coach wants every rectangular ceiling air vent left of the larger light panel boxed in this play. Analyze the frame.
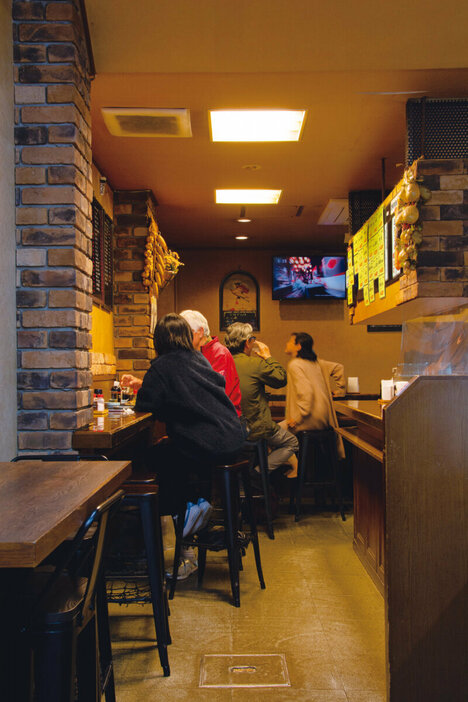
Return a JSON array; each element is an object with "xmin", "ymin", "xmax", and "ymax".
[{"xmin": 102, "ymin": 107, "xmax": 192, "ymax": 137}]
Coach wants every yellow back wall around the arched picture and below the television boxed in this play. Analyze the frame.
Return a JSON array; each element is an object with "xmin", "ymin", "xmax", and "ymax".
[{"xmin": 176, "ymin": 249, "xmax": 401, "ymax": 393}]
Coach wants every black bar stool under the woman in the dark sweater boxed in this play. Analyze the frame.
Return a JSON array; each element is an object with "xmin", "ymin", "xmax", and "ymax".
[{"xmin": 169, "ymin": 461, "xmax": 265, "ymax": 607}]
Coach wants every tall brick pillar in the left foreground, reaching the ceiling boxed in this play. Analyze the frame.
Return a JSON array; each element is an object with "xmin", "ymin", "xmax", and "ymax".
[{"xmin": 13, "ymin": 0, "xmax": 92, "ymax": 452}]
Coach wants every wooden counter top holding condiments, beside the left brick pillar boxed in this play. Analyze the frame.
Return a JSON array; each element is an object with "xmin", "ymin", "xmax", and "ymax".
[{"xmin": 72, "ymin": 412, "xmax": 153, "ymax": 449}]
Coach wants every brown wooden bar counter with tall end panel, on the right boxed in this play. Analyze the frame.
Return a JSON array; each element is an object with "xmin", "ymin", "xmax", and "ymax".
[{"xmin": 336, "ymin": 376, "xmax": 468, "ymax": 702}]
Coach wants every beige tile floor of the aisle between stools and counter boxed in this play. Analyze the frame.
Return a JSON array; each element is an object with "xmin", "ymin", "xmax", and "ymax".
[{"xmin": 111, "ymin": 512, "xmax": 385, "ymax": 702}]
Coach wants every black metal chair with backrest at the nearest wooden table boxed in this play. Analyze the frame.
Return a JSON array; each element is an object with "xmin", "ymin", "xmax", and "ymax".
[{"xmin": 21, "ymin": 490, "xmax": 124, "ymax": 702}]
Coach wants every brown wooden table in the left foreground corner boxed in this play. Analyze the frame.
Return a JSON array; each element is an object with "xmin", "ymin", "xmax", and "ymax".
[{"xmin": 0, "ymin": 461, "xmax": 131, "ymax": 702}]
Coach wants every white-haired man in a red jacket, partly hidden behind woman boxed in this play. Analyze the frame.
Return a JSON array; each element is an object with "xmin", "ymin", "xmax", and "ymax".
[{"xmin": 180, "ymin": 310, "xmax": 242, "ymax": 417}]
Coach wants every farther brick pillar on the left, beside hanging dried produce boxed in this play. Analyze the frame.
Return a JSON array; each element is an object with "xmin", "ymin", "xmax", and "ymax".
[{"xmin": 114, "ymin": 190, "xmax": 156, "ymax": 377}]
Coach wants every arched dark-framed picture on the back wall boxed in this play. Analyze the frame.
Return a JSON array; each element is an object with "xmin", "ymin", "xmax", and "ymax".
[{"xmin": 219, "ymin": 271, "xmax": 260, "ymax": 331}]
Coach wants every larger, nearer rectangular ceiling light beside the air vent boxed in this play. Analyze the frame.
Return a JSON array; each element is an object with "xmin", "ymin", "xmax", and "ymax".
[{"xmin": 210, "ymin": 110, "xmax": 306, "ymax": 141}]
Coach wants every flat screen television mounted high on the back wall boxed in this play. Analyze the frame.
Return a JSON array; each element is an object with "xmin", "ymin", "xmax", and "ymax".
[{"xmin": 273, "ymin": 255, "xmax": 346, "ymax": 300}]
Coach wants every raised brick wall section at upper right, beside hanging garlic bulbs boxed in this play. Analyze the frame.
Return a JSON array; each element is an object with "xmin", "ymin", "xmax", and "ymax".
[{"xmin": 400, "ymin": 159, "xmax": 468, "ymax": 304}]
